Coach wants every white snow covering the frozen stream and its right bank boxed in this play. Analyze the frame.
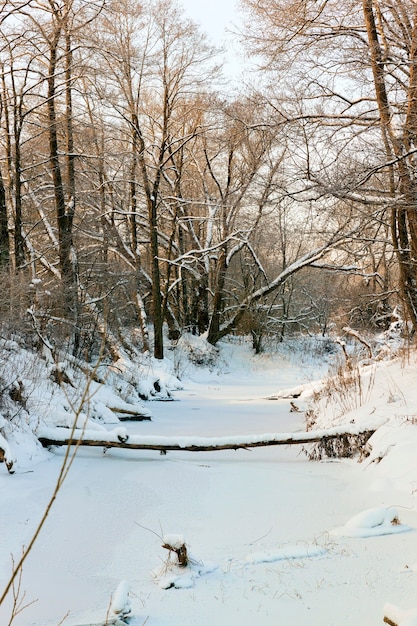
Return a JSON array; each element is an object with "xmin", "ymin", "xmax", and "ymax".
[{"xmin": 0, "ymin": 342, "xmax": 417, "ymax": 626}]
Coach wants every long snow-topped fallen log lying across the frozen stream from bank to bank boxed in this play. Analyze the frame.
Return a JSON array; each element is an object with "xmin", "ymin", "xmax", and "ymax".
[{"xmin": 37, "ymin": 420, "xmax": 381, "ymax": 452}]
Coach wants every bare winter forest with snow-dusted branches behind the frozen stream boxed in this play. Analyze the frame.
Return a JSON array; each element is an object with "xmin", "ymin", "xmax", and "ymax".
[{"xmin": 0, "ymin": 0, "xmax": 417, "ymax": 361}]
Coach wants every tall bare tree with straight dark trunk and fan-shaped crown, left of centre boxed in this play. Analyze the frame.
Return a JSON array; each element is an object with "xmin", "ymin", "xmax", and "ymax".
[{"xmin": 91, "ymin": 1, "xmax": 219, "ymax": 359}]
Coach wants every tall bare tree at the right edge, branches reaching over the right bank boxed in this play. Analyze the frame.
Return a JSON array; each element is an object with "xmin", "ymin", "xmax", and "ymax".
[{"xmin": 242, "ymin": 0, "xmax": 417, "ymax": 327}]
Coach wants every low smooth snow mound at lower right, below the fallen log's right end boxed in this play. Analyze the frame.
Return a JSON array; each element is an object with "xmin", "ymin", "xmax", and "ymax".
[{"xmin": 331, "ymin": 507, "xmax": 411, "ymax": 537}]
